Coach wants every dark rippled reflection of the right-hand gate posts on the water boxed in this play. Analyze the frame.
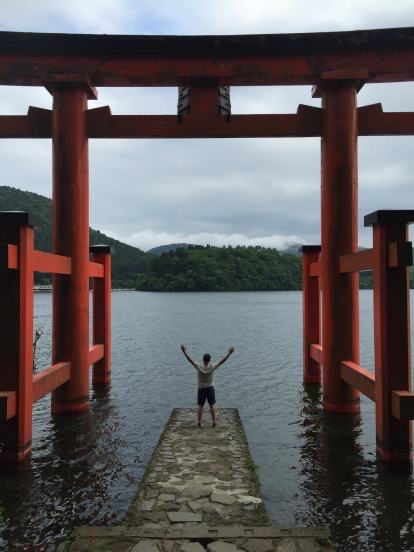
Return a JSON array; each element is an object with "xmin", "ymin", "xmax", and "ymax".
[{"xmin": 297, "ymin": 386, "xmax": 414, "ymax": 551}]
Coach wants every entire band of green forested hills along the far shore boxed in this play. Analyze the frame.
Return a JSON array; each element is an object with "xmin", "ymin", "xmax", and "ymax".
[{"xmin": 0, "ymin": 186, "xmax": 408, "ymax": 291}]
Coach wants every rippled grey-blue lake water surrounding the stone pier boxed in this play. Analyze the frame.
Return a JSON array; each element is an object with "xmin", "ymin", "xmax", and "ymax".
[{"xmin": 0, "ymin": 291, "xmax": 414, "ymax": 552}]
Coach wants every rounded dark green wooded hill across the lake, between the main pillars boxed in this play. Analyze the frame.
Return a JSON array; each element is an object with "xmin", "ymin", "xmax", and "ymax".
[{"xmin": 137, "ymin": 245, "xmax": 302, "ymax": 291}]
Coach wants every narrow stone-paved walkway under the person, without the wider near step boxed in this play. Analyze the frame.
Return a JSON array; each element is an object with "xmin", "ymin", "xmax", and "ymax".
[{"xmin": 125, "ymin": 409, "xmax": 269, "ymax": 527}]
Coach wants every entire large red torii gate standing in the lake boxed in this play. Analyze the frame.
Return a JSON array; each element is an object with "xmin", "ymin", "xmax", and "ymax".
[{"xmin": 0, "ymin": 28, "xmax": 414, "ymax": 462}]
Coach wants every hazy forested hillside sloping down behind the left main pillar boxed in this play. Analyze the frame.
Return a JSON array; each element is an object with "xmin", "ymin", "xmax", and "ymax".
[{"xmin": 0, "ymin": 186, "xmax": 154, "ymax": 288}]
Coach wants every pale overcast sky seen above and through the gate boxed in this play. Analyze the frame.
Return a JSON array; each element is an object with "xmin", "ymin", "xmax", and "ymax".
[{"xmin": 0, "ymin": 0, "xmax": 414, "ymax": 250}]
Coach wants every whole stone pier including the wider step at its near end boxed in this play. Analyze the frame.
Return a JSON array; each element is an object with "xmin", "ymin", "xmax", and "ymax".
[{"xmin": 69, "ymin": 408, "xmax": 333, "ymax": 552}]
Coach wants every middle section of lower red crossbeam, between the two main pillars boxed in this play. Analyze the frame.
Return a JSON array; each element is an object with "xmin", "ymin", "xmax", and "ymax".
[{"xmin": 86, "ymin": 105, "xmax": 322, "ymax": 138}]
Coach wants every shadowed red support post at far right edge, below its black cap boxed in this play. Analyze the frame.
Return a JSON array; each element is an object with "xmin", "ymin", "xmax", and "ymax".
[{"xmin": 373, "ymin": 224, "xmax": 412, "ymax": 462}]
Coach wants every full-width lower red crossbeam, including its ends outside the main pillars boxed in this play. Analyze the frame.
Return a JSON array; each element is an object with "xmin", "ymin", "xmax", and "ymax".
[{"xmin": 0, "ymin": 102, "xmax": 414, "ymax": 138}]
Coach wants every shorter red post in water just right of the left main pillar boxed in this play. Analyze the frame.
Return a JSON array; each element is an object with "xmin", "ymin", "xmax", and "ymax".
[{"xmin": 92, "ymin": 253, "xmax": 111, "ymax": 384}]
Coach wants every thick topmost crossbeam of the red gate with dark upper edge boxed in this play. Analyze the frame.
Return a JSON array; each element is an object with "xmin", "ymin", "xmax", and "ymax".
[{"xmin": 0, "ymin": 35, "xmax": 414, "ymax": 87}]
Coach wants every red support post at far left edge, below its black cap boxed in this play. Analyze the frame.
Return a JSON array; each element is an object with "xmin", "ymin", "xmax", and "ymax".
[{"xmin": 0, "ymin": 226, "xmax": 34, "ymax": 462}]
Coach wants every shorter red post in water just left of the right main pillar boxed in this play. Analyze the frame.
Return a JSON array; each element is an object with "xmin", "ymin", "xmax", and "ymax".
[{"xmin": 302, "ymin": 251, "xmax": 321, "ymax": 383}]
